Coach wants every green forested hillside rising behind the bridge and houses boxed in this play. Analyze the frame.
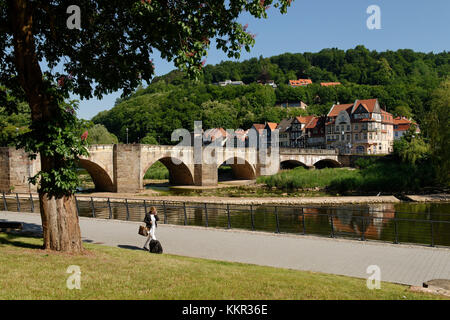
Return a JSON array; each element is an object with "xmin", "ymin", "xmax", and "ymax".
[{"xmin": 92, "ymin": 46, "xmax": 450, "ymax": 143}]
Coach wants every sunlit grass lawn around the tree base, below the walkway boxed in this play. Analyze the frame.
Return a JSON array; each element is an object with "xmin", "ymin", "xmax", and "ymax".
[{"xmin": 0, "ymin": 234, "xmax": 442, "ymax": 300}]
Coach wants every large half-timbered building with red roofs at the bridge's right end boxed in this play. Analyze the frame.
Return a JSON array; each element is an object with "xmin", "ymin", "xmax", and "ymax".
[{"xmin": 325, "ymin": 99, "xmax": 394, "ymax": 154}]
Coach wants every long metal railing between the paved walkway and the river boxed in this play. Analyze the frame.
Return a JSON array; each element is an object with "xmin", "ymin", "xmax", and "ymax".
[{"xmin": 2, "ymin": 193, "xmax": 450, "ymax": 247}]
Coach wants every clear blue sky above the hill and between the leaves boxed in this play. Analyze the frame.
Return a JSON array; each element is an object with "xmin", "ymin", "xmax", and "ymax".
[{"xmin": 72, "ymin": 0, "xmax": 450, "ymax": 119}]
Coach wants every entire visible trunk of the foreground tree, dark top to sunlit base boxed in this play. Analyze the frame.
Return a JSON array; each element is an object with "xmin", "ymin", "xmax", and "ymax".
[{"xmin": 8, "ymin": 0, "xmax": 83, "ymax": 253}]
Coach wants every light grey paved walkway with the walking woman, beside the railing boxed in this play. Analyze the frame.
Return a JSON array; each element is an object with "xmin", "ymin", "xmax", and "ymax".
[{"xmin": 0, "ymin": 212, "xmax": 450, "ymax": 286}]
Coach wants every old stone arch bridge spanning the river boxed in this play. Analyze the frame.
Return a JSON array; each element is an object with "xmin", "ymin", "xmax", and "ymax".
[{"xmin": 0, "ymin": 144, "xmax": 340, "ymax": 192}]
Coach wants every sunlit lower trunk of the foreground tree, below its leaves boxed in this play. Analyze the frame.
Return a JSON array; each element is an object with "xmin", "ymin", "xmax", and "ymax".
[{"xmin": 39, "ymin": 193, "xmax": 83, "ymax": 253}]
